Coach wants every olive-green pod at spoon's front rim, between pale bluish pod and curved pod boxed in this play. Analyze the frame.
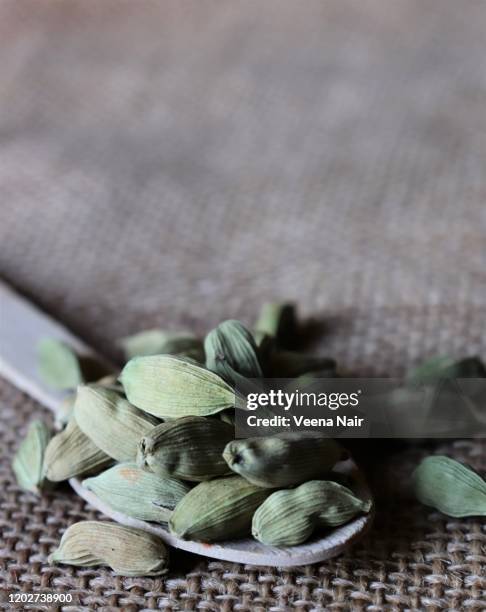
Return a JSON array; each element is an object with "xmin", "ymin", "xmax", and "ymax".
[{"xmin": 169, "ymin": 476, "xmax": 271, "ymax": 542}]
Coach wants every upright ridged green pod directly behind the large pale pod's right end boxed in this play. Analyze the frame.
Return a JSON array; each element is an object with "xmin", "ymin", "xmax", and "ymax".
[{"xmin": 204, "ymin": 320, "xmax": 262, "ymax": 384}]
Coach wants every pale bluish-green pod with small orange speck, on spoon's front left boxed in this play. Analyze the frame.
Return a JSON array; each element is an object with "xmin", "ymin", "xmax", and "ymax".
[{"xmin": 83, "ymin": 463, "xmax": 191, "ymax": 523}]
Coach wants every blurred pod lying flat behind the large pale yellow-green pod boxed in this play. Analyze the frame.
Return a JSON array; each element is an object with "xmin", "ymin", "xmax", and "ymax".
[{"xmin": 121, "ymin": 329, "xmax": 204, "ymax": 363}]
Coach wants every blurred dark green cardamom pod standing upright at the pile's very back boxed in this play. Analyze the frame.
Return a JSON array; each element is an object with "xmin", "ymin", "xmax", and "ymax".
[{"xmin": 253, "ymin": 302, "xmax": 297, "ymax": 348}]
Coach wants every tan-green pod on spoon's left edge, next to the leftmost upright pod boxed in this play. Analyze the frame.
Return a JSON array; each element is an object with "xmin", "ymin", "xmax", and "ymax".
[{"xmin": 44, "ymin": 417, "xmax": 113, "ymax": 482}]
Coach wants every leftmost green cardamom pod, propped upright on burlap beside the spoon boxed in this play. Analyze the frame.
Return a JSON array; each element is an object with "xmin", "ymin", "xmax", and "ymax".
[{"xmin": 12, "ymin": 420, "xmax": 51, "ymax": 493}]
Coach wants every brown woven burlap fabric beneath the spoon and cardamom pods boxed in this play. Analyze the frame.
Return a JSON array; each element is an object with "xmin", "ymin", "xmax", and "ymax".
[{"xmin": 0, "ymin": 0, "xmax": 486, "ymax": 612}]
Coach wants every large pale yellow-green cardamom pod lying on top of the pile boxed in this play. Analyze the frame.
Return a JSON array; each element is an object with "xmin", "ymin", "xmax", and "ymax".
[{"xmin": 120, "ymin": 355, "xmax": 235, "ymax": 418}]
